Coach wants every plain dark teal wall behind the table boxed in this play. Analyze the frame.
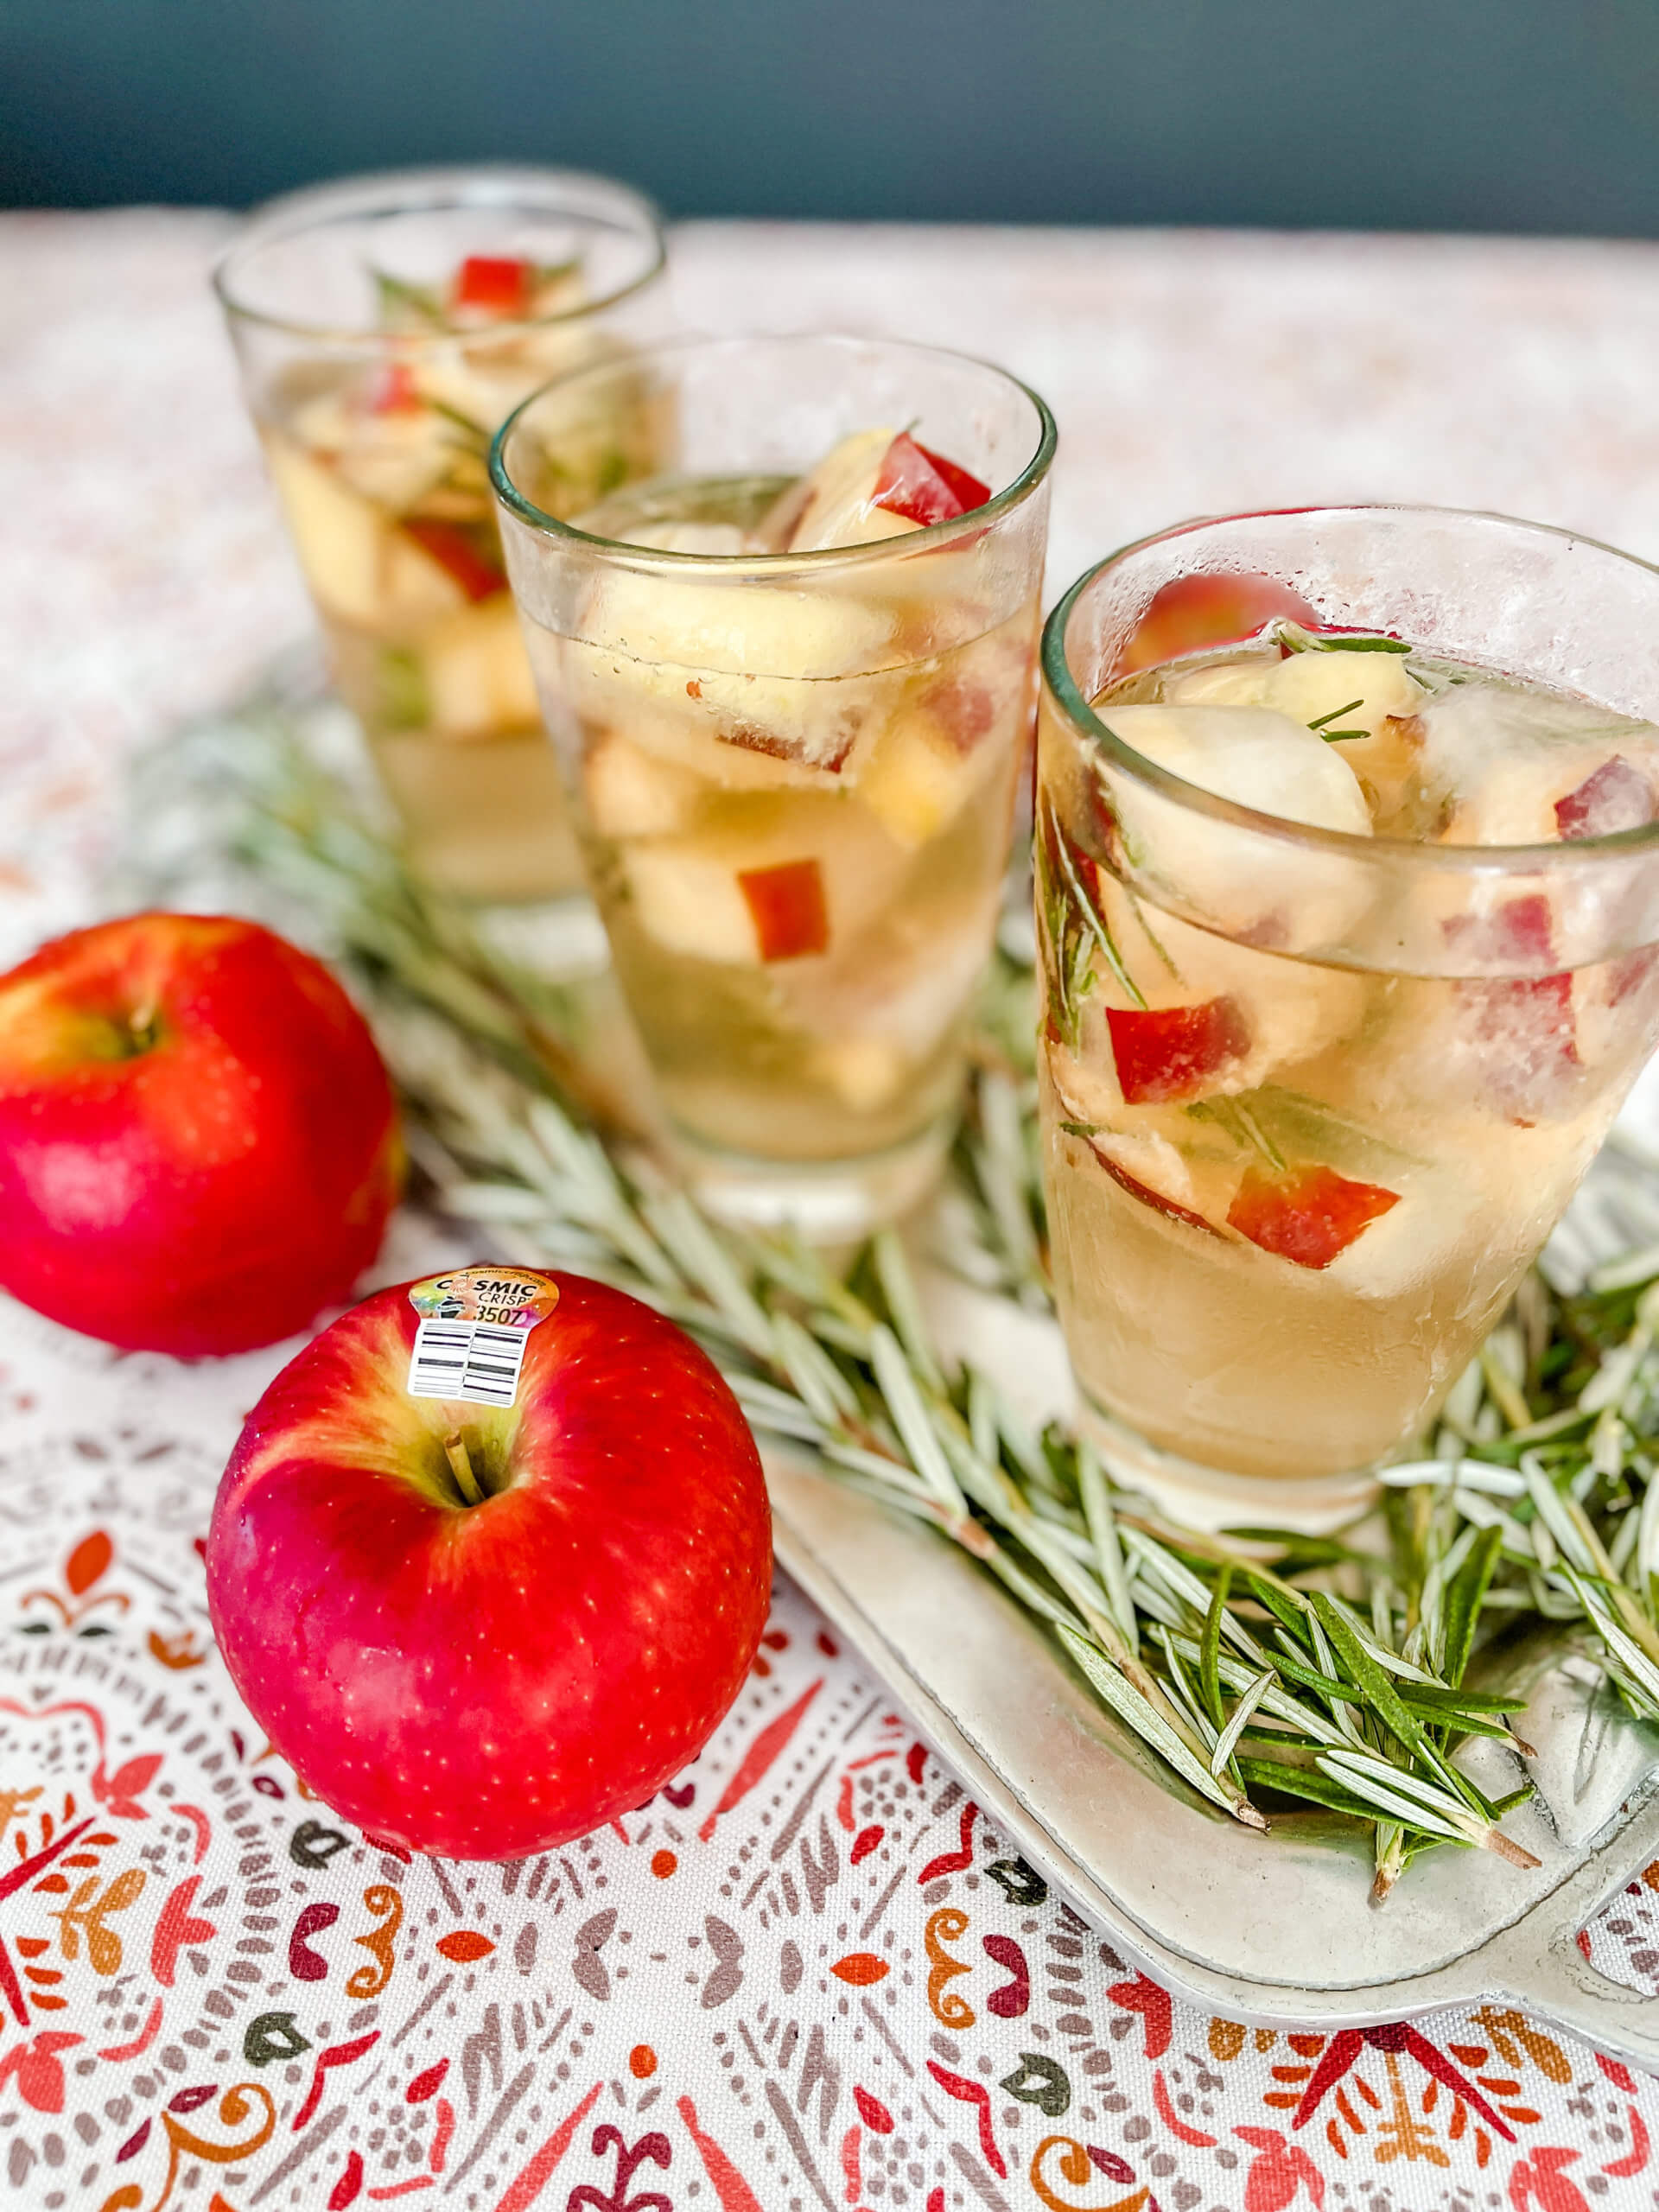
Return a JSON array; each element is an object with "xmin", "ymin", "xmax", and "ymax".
[{"xmin": 0, "ymin": 0, "xmax": 1659, "ymax": 234}]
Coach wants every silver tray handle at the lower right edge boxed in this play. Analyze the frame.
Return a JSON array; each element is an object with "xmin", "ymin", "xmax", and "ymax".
[{"xmin": 1493, "ymin": 1794, "xmax": 1659, "ymax": 2070}]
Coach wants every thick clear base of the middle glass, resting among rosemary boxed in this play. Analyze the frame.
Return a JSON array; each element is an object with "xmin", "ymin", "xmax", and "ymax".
[{"xmin": 672, "ymin": 1119, "xmax": 956, "ymax": 1243}]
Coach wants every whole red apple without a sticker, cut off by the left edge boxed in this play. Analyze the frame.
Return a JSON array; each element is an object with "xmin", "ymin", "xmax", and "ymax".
[{"xmin": 0, "ymin": 913, "xmax": 403, "ymax": 1356}]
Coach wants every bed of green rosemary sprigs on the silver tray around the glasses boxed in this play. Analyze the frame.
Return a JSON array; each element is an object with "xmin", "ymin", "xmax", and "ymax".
[{"xmin": 117, "ymin": 692, "xmax": 1659, "ymax": 1896}]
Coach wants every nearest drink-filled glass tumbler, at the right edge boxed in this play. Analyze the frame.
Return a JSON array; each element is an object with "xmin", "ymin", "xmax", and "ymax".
[{"xmin": 1035, "ymin": 506, "xmax": 1659, "ymax": 1520}]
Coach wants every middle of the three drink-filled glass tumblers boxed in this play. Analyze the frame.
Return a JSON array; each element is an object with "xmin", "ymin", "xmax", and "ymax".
[{"xmin": 493, "ymin": 336, "xmax": 1055, "ymax": 1236}]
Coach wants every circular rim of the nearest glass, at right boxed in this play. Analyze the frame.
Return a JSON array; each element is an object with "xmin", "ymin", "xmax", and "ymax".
[{"xmin": 1052, "ymin": 500, "xmax": 1659, "ymax": 876}]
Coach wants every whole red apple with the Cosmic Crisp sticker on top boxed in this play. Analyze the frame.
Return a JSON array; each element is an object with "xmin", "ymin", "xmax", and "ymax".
[{"xmin": 208, "ymin": 1269, "xmax": 772, "ymax": 1858}]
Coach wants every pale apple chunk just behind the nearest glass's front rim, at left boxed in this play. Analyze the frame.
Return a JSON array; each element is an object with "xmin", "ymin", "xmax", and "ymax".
[{"xmin": 1099, "ymin": 706, "xmax": 1371, "ymax": 836}]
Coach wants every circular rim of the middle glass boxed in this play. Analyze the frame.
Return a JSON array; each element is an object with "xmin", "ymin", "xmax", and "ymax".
[{"xmin": 489, "ymin": 329, "xmax": 1059, "ymax": 577}]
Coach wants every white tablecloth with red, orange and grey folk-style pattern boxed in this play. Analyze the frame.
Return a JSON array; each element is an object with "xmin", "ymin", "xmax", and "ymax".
[{"xmin": 0, "ymin": 210, "xmax": 1659, "ymax": 2212}]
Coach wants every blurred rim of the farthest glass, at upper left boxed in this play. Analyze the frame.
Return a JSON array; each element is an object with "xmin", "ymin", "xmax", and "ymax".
[{"xmin": 210, "ymin": 162, "xmax": 668, "ymax": 352}]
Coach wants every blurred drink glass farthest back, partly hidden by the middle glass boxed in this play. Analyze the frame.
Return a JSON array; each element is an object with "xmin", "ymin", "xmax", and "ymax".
[{"xmin": 214, "ymin": 168, "xmax": 666, "ymax": 942}]
